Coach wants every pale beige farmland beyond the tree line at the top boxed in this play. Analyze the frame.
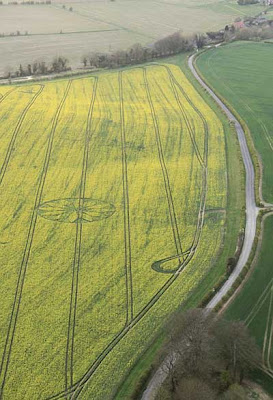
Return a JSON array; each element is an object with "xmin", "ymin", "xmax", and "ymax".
[{"xmin": 0, "ymin": 0, "xmax": 263, "ymax": 74}]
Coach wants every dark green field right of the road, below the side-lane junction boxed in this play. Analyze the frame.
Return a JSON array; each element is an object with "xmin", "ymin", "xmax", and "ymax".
[{"xmin": 226, "ymin": 216, "xmax": 273, "ymax": 394}]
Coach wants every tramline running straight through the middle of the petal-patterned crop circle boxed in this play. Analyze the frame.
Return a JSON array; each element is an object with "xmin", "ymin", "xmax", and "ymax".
[{"xmin": 65, "ymin": 78, "xmax": 98, "ymax": 390}]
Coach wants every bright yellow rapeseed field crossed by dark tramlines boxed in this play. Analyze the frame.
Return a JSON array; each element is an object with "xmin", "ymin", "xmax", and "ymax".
[{"xmin": 0, "ymin": 64, "xmax": 227, "ymax": 400}]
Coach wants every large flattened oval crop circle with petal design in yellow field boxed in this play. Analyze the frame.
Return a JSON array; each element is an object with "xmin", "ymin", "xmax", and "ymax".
[{"xmin": 38, "ymin": 199, "xmax": 116, "ymax": 223}]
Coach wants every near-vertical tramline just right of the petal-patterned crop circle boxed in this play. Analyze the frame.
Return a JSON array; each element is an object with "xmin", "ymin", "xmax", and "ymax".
[{"xmin": 118, "ymin": 71, "xmax": 133, "ymax": 326}]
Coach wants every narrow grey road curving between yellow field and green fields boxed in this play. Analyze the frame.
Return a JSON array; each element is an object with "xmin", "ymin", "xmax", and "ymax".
[{"xmin": 141, "ymin": 51, "xmax": 259, "ymax": 400}]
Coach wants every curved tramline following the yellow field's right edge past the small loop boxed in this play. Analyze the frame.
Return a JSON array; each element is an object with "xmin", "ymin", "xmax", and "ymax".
[{"xmin": 46, "ymin": 67, "xmax": 208, "ymax": 400}]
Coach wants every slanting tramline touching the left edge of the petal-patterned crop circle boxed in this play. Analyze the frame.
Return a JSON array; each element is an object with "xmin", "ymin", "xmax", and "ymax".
[{"xmin": 0, "ymin": 80, "xmax": 72, "ymax": 399}]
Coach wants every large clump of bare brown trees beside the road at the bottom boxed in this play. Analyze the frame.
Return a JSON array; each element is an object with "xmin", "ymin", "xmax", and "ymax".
[{"xmin": 155, "ymin": 309, "xmax": 261, "ymax": 400}]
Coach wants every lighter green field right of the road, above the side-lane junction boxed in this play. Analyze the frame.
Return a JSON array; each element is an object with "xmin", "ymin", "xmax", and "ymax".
[{"xmin": 197, "ymin": 42, "xmax": 273, "ymax": 202}]
